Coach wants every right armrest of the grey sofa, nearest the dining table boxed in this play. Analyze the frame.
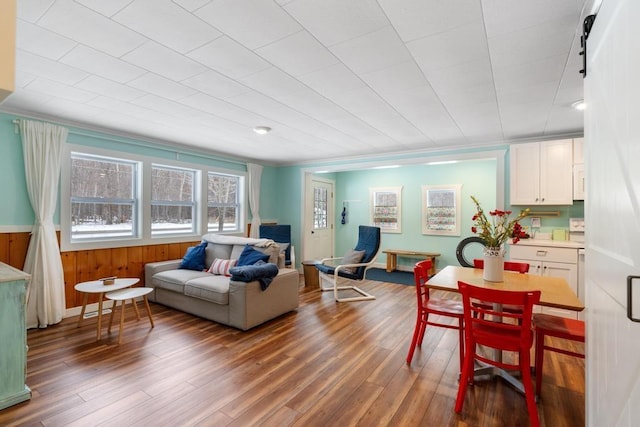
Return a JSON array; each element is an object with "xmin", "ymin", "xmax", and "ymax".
[{"xmin": 229, "ymin": 268, "xmax": 300, "ymax": 331}]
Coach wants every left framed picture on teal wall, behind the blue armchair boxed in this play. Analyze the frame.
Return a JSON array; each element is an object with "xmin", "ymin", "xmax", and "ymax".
[{"xmin": 369, "ymin": 186, "xmax": 402, "ymax": 233}]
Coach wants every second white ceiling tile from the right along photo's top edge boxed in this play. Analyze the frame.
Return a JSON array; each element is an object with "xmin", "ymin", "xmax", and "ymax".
[{"xmin": 379, "ymin": 0, "xmax": 482, "ymax": 42}]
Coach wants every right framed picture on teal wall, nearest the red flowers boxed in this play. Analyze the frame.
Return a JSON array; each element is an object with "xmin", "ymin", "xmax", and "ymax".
[{"xmin": 422, "ymin": 184, "xmax": 462, "ymax": 236}]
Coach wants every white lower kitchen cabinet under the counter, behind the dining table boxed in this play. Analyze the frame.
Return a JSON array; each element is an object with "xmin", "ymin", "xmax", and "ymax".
[{"xmin": 509, "ymin": 244, "xmax": 578, "ymax": 319}]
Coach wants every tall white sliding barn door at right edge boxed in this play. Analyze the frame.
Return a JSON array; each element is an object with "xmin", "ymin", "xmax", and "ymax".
[{"xmin": 584, "ymin": 0, "xmax": 640, "ymax": 427}]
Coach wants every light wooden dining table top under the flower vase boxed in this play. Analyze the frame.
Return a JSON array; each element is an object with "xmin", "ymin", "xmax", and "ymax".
[{"xmin": 426, "ymin": 265, "xmax": 584, "ymax": 311}]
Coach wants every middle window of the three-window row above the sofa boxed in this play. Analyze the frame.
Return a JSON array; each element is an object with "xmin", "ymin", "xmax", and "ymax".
[{"xmin": 151, "ymin": 165, "xmax": 196, "ymax": 237}]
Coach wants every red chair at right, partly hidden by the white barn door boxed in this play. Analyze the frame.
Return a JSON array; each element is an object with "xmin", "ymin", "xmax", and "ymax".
[{"xmin": 533, "ymin": 314, "xmax": 584, "ymax": 396}]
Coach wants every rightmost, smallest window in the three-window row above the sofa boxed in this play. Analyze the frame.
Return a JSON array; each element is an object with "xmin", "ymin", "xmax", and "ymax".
[{"xmin": 207, "ymin": 173, "xmax": 242, "ymax": 232}]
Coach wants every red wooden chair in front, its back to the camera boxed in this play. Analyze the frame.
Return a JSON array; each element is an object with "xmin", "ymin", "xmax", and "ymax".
[{"xmin": 455, "ymin": 282, "xmax": 540, "ymax": 427}]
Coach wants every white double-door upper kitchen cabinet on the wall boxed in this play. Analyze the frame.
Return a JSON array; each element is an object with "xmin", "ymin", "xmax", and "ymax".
[{"xmin": 509, "ymin": 139, "xmax": 573, "ymax": 205}]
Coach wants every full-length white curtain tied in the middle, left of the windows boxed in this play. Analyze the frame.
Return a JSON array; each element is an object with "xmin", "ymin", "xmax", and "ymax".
[{"xmin": 20, "ymin": 120, "xmax": 68, "ymax": 328}]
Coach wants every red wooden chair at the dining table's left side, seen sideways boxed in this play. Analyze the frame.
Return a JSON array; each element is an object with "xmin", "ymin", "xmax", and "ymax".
[{"xmin": 407, "ymin": 260, "xmax": 464, "ymax": 369}]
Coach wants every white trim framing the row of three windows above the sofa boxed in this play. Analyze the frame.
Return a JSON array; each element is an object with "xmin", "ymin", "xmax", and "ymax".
[{"xmin": 58, "ymin": 144, "xmax": 248, "ymax": 252}]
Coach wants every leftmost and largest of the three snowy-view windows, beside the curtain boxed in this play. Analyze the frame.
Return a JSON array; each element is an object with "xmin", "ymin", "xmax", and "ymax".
[{"xmin": 70, "ymin": 153, "xmax": 139, "ymax": 241}]
